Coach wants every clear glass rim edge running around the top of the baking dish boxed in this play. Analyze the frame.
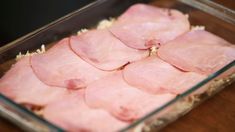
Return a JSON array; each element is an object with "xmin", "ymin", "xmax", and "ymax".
[{"xmin": 0, "ymin": 0, "xmax": 235, "ymax": 132}]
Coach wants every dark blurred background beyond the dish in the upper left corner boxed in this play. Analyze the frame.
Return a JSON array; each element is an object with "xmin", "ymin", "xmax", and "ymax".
[{"xmin": 0, "ymin": 0, "xmax": 94, "ymax": 46}]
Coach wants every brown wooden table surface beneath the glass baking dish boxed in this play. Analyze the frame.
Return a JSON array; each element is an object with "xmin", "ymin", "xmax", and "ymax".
[{"xmin": 0, "ymin": 0, "xmax": 235, "ymax": 132}]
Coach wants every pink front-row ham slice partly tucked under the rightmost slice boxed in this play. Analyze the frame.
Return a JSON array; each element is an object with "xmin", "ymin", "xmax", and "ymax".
[{"xmin": 123, "ymin": 56, "xmax": 206, "ymax": 94}]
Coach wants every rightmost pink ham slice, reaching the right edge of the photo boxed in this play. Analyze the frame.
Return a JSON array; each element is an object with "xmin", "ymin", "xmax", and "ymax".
[{"xmin": 158, "ymin": 30, "xmax": 235, "ymax": 75}]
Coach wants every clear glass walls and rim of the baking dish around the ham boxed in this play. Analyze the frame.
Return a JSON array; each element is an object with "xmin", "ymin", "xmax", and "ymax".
[{"xmin": 0, "ymin": 0, "xmax": 235, "ymax": 131}]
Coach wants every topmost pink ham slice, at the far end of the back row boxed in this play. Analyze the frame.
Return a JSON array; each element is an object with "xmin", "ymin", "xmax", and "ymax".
[{"xmin": 110, "ymin": 4, "xmax": 190, "ymax": 49}]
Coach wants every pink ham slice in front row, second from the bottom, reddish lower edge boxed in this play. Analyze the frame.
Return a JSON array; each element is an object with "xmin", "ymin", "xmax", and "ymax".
[{"xmin": 85, "ymin": 71, "xmax": 175, "ymax": 121}]
